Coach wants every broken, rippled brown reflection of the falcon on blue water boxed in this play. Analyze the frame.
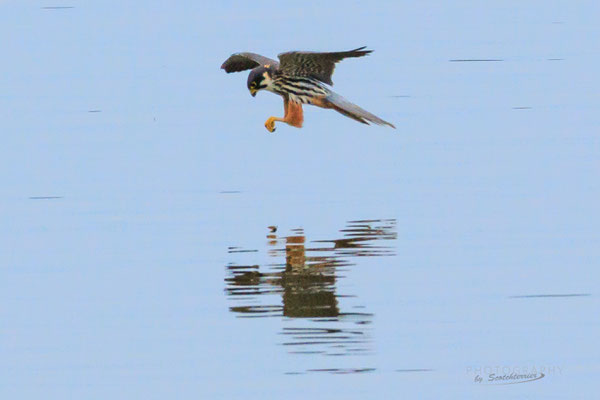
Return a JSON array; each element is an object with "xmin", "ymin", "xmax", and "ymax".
[{"xmin": 225, "ymin": 220, "xmax": 396, "ymax": 364}]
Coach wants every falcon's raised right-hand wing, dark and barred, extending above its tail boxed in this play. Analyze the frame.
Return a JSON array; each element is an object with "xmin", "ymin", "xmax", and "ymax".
[{"xmin": 278, "ymin": 46, "xmax": 373, "ymax": 85}]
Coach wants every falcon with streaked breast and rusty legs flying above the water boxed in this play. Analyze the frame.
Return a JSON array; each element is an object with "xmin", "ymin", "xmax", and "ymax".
[{"xmin": 221, "ymin": 47, "xmax": 396, "ymax": 132}]
